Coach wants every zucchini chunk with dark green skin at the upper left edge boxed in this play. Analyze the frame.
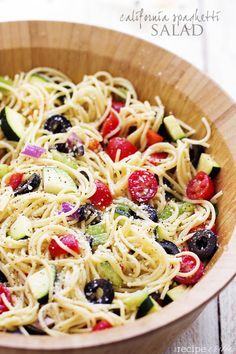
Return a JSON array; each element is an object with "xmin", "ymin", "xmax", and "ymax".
[{"xmin": 0, "ymin": 107, "xmax": 25, "ymax": 141}]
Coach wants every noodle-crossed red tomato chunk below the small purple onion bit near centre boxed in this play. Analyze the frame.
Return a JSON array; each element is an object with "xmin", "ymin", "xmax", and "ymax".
[{"xmin": 48, "ymin": 235, "xmax": 80, "ymax": 258}]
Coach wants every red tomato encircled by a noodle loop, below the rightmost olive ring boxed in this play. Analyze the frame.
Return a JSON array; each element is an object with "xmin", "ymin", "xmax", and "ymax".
[{"xmin": 174, "ymin": 255, "xmax": 204, "ymax": 285}]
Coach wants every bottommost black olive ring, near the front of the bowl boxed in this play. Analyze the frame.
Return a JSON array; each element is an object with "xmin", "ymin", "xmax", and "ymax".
[{"xmin": 84, "ymin": 279, "xmax": 114, "ymax": 304}]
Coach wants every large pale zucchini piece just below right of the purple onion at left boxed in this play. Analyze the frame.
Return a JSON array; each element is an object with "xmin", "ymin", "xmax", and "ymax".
[{"xmin": 43, "ymin": 167, "xmax": 77, "ymax": 194}]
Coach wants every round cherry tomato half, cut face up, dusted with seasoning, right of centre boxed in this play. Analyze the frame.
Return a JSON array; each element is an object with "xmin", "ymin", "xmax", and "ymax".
[{"xmin": 128, "ymin": 170, "xmax": 158, "ymax": 202}]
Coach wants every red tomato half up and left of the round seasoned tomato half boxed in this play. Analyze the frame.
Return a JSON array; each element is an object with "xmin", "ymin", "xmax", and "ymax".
[{"xmin": 105, "ymin": 137, "xmax": 137, "ymax": 161}]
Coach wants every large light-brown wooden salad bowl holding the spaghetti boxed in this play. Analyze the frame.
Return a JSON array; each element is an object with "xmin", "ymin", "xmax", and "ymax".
[{"xmin": 0, "ymin": 22, "xmax": 236, "ymax": 354}]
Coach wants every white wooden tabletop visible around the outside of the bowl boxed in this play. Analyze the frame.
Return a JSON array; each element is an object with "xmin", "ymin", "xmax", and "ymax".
[{"xmin": 0, "ymin": 0, "xmax": 236, "ymax": 354}]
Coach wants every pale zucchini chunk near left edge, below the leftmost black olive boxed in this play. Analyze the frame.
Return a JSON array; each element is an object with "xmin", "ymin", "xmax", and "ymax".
[{"xmin": 8, "ymin": 215, "xmax": 32, "ymax": 241}]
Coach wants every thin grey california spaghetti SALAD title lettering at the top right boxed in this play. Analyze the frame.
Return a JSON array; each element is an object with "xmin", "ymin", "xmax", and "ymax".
[{"xmin": 120, "ymin": 8, "xmax": 221, "ymax": 37}]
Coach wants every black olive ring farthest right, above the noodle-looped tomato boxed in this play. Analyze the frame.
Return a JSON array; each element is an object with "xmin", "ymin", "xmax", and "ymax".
[{"xmin": 187, "ymin": 229, "xmax": 217, "ymax": 261}]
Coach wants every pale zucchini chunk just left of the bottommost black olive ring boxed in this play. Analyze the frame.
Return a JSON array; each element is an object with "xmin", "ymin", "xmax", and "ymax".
[{"xmin": 28, "ymin": 266, "xmax": 56, "ymax": 301}]
